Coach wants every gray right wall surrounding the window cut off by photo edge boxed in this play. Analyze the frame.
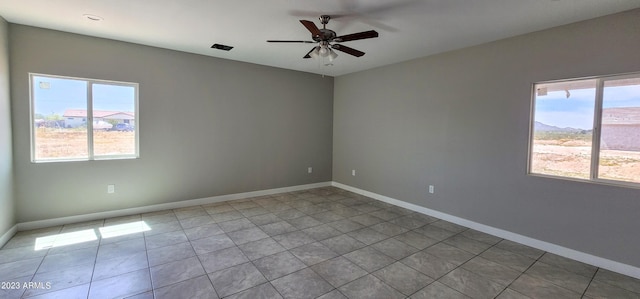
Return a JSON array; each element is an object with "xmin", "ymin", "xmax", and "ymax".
[{"xmin": 333, "ymin": 10, "xmax": 640, "ymax": 267}]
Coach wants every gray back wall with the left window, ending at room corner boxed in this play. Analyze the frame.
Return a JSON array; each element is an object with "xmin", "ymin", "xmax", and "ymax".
[{"xmin": 10, "ymin": 24, "xmax": 333, "ymax": 222}]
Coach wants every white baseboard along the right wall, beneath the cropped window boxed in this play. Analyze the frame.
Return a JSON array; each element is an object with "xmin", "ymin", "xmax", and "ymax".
[{"xmin": 331, "ymin": 182, "xmax": 640, "ymax": 279}]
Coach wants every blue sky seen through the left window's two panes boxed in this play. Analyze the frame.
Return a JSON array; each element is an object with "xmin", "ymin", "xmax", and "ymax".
[{"xmin": 33, "ymin": 76, "xmax": 135, "ymax": 115}]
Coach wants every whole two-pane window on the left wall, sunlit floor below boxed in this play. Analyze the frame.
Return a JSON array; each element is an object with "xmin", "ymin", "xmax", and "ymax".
[{"xmin": 30, "ymin": 74, "xmax": 139, "ymax": 162}]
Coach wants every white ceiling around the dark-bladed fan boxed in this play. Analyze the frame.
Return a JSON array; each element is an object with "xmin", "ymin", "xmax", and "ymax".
[{"xmin": 0, "ymin": 0, "xmax": 640, "ymax": 76}]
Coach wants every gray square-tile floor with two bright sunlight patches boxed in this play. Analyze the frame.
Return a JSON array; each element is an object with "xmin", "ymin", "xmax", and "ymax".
[{"xmin": 0, "ymin": 187, "xmax": 640, "ymax": 299}]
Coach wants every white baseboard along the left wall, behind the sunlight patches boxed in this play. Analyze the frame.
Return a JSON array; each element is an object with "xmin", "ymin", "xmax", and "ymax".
[{"xmin": 17, "ymin": 182, "xmax": 331, "ymax": 232}]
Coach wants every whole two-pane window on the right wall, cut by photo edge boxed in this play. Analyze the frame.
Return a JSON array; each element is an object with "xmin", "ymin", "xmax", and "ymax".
[{"xmin": 529, "ymin": 74, "xmax": 640, "ymax": 186}]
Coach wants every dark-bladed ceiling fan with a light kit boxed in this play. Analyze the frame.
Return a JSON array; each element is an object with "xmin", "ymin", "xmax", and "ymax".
[{"xmin": 267, "ymin": 15, "xmax": 378, "ymax": 61}]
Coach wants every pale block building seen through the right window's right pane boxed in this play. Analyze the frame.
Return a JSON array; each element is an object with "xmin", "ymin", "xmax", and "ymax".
[{"xmin": 600, "ymin": 107, "xmax": 640, "ymax": 151}]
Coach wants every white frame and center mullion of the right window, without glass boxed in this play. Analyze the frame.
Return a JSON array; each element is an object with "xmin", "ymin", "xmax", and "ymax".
[{"xmin": 527, "ymin": 72, "xmax": 640, "ymax": 189}]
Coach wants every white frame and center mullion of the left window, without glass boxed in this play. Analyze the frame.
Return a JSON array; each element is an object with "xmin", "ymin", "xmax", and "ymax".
[{"xmin": 29, "ymin": 73, "xmax": 140, "ymax": 163}]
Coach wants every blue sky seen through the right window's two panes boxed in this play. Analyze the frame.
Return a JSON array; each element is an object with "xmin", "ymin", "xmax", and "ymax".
[{"xmin": 535, "ymin": 85, "xmax": 640, "ymax": 130}]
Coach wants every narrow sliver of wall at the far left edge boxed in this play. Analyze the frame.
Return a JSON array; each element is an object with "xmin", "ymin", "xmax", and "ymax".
[{"xmin": 0, "ymin": 17, "xmax": 15, "ymax": 238}]
